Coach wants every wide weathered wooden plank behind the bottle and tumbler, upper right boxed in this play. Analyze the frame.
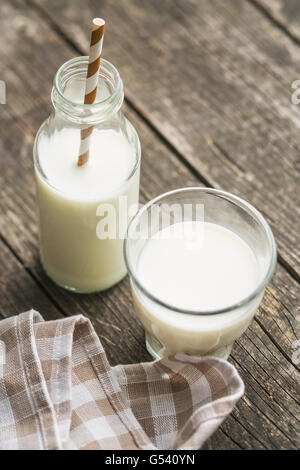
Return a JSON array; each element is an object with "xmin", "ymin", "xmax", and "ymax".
[{"xmin": 26, "ymin": 0, "xmax": 300, "ymax": 277}]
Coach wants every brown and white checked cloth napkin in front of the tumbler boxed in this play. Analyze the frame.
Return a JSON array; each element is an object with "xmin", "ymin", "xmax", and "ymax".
[{"xmin": 0, "ymin": 310, "xmax": 244, "ymax": 450}]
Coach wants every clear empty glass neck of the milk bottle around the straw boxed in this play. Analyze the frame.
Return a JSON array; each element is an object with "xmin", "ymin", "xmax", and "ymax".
[{"xmin": 51, "ymin": 56, "xmax": 124, "ymax": 125}]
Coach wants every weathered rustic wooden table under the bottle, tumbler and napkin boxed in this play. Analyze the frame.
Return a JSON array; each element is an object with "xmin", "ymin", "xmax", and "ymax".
[{"xmin": 0, "ymin": 0, "xmax": 300, "ymax": 449}]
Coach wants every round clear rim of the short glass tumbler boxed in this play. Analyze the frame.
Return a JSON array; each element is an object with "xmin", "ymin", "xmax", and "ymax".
[{"xmin": 123, "ymin": 186, "xmax": 277, "ymax": 316}]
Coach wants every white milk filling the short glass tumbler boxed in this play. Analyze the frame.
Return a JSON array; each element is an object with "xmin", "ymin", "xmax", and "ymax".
[{"xmin": 132, "ymin": 221, "xmax": 263, "ymax": 358}]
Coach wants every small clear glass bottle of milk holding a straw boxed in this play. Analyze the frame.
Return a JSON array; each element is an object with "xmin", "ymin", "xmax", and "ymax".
[{"xmin": 33, "ymin": 57, "xmax": 141, "ymax": 293}]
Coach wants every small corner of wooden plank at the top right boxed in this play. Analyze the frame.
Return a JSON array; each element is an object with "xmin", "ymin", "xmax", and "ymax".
[{"xmin": 250, "ymin": 0, "xmax": 300, "ymax": 44}]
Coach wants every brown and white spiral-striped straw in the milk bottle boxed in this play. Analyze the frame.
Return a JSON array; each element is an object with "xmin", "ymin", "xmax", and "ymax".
[{"xmin": 77, "ymin": 18, "xmax": 105, "ymax": 166}]
